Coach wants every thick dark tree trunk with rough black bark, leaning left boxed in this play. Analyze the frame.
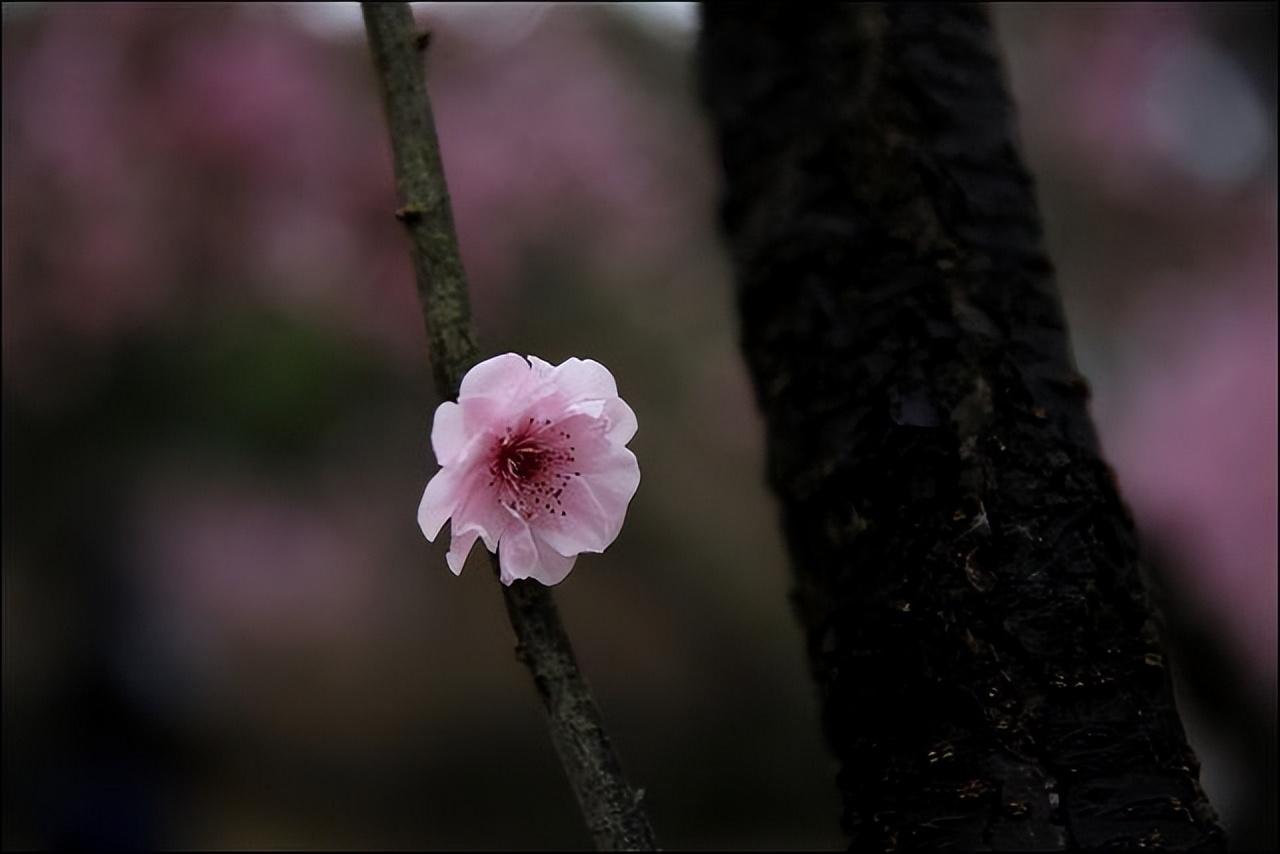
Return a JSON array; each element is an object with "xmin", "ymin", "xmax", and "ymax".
[{"xmin": 700, "ymin": 4, "xmax": 1225, "ymax": 850}]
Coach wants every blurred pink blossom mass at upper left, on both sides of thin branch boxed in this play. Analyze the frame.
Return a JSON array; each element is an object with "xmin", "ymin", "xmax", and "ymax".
[{"xmin": 3, "ymin": 5, "xmax": 710, "ymax": 393}]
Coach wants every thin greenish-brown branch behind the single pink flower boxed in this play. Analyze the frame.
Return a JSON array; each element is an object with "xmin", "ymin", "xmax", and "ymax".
[{"xmin": 361, "ymin": 3, "xmax": 655, "ymax": 850}]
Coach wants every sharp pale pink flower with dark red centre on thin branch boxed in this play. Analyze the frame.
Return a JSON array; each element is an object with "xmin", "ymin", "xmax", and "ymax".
[{"xmin": 417, "ymin": 353, "xmax": 640, "ymax": 585}]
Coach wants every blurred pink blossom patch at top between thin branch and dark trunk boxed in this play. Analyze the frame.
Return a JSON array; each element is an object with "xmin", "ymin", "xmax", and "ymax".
[{"xmin": 428, "ymin": 6, "xmax": 714, "ymax": 290}]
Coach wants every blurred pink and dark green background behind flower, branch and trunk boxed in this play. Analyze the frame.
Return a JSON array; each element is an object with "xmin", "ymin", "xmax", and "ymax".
[{"xmin": 3, "ymin": 3, "xmax": 1277, "ymax": 849}]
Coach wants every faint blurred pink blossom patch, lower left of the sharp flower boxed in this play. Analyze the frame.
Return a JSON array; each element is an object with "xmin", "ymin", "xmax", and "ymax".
[{"xmin": 131, "ymin": 470, "xmax": 397, "ymax": 666}]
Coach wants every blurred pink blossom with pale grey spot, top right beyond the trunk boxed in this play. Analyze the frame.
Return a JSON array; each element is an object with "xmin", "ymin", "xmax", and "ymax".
[{"xmin": 1009, "ymin": 3, "xmax": 1272, "ymax": 204}]
